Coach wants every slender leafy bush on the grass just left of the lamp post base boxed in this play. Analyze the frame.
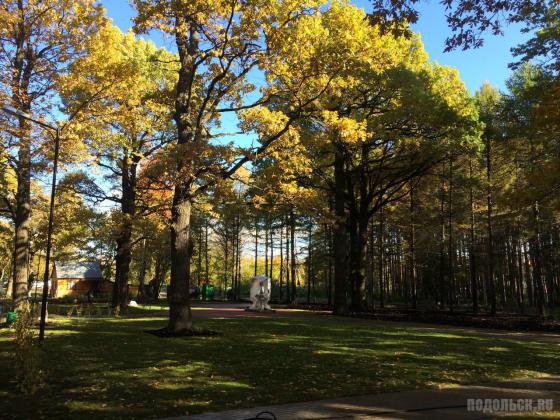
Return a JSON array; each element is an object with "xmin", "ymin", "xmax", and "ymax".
[{"xmin": 14, "ymin": 305, "xmax": 45, "ymax": 395}]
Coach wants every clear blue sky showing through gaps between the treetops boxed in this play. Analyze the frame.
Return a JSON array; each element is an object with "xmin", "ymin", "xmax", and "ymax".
[{"xmin": 102, "ymin": 0, "xmax": 527, "ymax": 92}]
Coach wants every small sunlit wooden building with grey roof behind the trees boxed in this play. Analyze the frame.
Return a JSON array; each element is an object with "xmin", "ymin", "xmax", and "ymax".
[{"xmin": 51, "ymin": 261, "xmax": 113, "ymax": 298}]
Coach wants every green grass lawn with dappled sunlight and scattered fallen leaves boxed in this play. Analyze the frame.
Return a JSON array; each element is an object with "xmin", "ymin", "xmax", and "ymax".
[{"xmin": 0, "ymin": 311, "xmax": 560, "ymax": 419}]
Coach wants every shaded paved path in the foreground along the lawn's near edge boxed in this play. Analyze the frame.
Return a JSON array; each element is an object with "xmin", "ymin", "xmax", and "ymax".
[{"xmin": 177, "ymin": 376, "xmax": 560, "ymax": 420}]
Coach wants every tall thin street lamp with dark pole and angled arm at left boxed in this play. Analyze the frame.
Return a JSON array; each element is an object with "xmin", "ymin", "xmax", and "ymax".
[{"xmin": 2, "ymin": 106, "xmax": 60, "ymax": 341}]
